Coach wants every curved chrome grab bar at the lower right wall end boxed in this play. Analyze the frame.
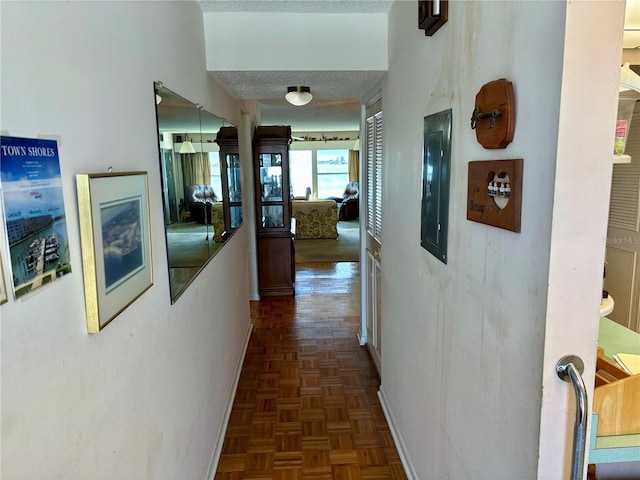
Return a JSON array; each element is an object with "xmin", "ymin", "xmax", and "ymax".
[{"xmin": 556, "ymin": 355, "xmax": 588, "ymax": 480}]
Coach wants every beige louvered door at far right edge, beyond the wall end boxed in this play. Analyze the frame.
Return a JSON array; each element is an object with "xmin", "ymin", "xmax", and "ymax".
[{"xmin": 604, "ymin": 102, "xmax": 640, "ymax": 333}]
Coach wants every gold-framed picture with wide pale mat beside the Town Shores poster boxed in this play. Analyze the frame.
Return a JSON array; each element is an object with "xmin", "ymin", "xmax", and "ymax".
[{"xmin": 76, "ymin": 172, "xmax": 153, "ymax": 333}]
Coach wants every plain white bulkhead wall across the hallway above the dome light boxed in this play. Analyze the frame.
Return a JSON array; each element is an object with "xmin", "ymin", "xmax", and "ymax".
[{"xmin": 204, "ymin": 12, "xmax": 387, "ymax": 71}]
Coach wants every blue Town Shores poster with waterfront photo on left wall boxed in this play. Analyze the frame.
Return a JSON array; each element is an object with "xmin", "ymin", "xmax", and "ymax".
[{"xmin": 0, "ymin": 136, "xmax": 71, "ymax": 298}]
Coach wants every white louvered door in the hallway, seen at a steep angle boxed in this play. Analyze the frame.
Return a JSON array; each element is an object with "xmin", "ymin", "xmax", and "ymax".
[{"xmin": 364, "ymin": 100, "xmax": 383, "ymax": 372}]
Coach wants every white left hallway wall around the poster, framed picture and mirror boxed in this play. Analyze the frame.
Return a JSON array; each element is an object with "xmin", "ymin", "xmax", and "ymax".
[{"xmin": 0, "ymin": 2, "xmax": 250, "ymax": 479}]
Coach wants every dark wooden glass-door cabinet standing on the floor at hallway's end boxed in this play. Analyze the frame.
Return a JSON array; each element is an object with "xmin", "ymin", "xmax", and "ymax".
[{"xmin": 253, "ymin": 126, "xmax": 295, "ymax": 296}]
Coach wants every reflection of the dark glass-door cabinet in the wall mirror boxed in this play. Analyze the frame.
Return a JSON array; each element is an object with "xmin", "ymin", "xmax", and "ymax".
[{"xmin": 216, "ymin": 127, "xmax": 242, "ymax": 240}]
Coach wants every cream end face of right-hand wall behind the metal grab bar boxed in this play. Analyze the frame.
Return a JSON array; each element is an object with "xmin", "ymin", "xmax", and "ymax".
[{"xmin": 536, "ymin": 1, "xmax": 625, "ymax": 480}]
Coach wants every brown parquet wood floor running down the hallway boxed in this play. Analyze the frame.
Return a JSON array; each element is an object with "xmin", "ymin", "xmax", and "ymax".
[{"xmin": 215, "ymin": 262, "xmax": 406, "ymax": 480}]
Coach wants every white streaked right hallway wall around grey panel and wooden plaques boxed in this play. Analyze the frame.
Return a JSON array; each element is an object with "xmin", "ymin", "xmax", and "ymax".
[{"xmin": 382, "ymin": 1, "xmax": 565, "ymax": 480}]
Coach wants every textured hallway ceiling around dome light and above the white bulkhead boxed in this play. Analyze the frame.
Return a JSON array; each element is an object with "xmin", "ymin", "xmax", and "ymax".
[{"xmin": 198, "ymin": 0, "xmax": 393, "ymax": 132}]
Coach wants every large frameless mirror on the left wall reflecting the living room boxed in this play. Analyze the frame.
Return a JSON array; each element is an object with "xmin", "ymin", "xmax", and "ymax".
[{"xmin": 154, "ymin": 82, "xmax": 242, "ymax": 303}]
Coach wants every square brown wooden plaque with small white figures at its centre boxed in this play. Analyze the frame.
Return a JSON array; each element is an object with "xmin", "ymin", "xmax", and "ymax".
[{"xmin": 467, "ymin": 158, "xmax": 522, "ymax": 232}]
